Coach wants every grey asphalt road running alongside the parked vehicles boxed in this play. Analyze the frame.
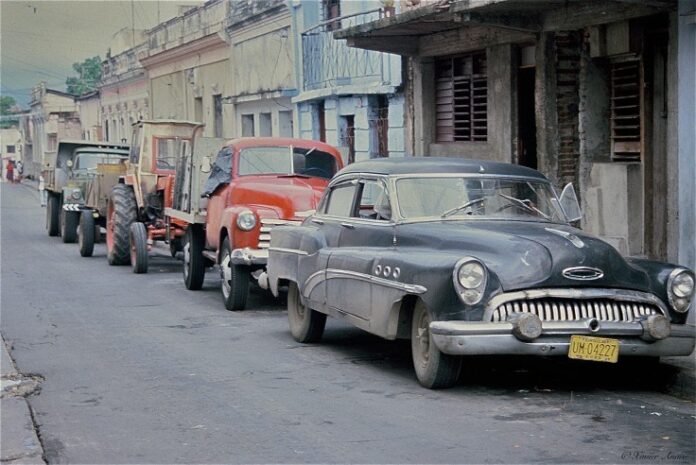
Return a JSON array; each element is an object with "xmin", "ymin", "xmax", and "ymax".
[{"xmin": 0, "ymin": 184, "xmax": 696, "ymax": 464}]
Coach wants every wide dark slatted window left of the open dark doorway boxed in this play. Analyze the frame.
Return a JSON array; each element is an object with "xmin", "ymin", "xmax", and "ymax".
[{"xmin": 435, "ymin": 51, "xmax": 488, "ymax": 142}]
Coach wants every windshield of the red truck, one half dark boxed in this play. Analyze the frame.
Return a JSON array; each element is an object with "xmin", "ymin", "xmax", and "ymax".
[{"xmin": 238, "ymin": 146, "xmax": 337, "ymax": 179}]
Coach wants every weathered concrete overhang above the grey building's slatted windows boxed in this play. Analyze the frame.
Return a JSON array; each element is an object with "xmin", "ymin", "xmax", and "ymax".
[{"xmin": 334, "ymin": 0, "xmax": 677, "ymax": 56}]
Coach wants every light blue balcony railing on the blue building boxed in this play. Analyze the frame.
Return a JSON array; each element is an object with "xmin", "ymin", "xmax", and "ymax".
[{"xmin": 302, "ymin": 9, "xmax": 388, "ymax": 91}]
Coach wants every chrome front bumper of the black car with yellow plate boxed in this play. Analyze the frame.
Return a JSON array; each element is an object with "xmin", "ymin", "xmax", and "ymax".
[{"xmin": 430, "ymin": 318, "xmax": 696, "ymax": 356}]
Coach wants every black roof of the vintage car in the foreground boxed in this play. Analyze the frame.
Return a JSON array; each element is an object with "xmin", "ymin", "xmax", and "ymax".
[{"xmin": 336, "ymin": 157, "xmax": 547, "ymax": 181}]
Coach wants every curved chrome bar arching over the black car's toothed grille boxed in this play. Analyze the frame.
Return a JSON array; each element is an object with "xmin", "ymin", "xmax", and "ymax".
[{"xmin": 483, "ymin": 288, "xmax": 669, "ymax": 321}]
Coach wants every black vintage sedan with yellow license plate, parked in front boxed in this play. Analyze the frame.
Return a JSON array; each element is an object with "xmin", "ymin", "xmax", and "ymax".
[{"xmin": 268, "ymin": 158, "xmax": 695, "ymax": 388}]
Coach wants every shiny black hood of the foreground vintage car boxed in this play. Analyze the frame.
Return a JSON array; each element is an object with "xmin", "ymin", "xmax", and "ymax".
[{"xmin": 399, "ymin": 220, "xmax": 650, "ymax": 292}]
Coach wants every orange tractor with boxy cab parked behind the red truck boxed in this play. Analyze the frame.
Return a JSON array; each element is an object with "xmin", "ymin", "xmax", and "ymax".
[{"xmin": 106, "ymin": 120, "xmax": 203, "ymax": 273}]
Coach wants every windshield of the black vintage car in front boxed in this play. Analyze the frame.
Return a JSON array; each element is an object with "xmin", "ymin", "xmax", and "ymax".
[{"xmin": 396, "ymin": 176, "xmax": 566, "ymax": 223}]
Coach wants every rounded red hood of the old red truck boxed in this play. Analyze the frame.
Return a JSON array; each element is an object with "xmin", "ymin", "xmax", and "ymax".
[{"xmin": 232, "ymin": 176, "xmax": 329, "ymax": 219}]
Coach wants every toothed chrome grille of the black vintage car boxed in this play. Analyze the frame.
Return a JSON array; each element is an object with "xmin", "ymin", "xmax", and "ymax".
[{"xmin": 491, "ymin": 298, "xmax": 661, "ymax": 322}]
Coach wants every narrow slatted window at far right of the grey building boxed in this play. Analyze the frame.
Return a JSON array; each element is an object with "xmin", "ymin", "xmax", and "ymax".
[{"xmin": 611, "ymin": 60, "xmax": 641, "ymax": 161}]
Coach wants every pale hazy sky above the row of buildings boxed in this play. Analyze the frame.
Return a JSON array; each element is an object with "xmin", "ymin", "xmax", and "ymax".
[{"xmin": 0, "ymin": 0, "xmax": 200, "ymax": 108}]
